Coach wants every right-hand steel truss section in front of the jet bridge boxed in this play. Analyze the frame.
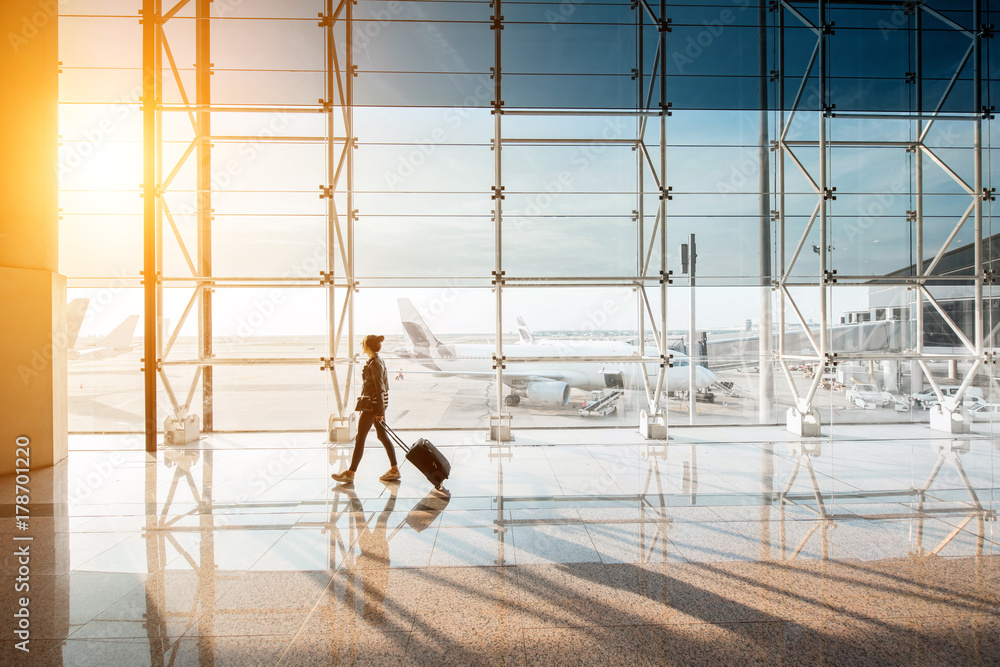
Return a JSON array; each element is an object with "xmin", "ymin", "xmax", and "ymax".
[{"xmin": 772, "ymin": 0, "xmax": 992, "ymax": 430}]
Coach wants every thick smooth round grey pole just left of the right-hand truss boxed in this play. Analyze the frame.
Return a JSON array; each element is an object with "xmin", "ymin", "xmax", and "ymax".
[{"xmin": 757, "ymin": 2, "xmax": 780, "ymax": 424}]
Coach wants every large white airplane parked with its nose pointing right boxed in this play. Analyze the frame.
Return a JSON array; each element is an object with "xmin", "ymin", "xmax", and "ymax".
[{"xmin": 395, "ymin": 299, "xmax": 716, "ymax": 406}]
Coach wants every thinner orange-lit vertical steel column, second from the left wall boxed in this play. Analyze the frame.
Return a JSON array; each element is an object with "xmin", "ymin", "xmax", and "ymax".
[{"xmin": 195, "ymin": 0, "xmax": 213, "ymax": 432}]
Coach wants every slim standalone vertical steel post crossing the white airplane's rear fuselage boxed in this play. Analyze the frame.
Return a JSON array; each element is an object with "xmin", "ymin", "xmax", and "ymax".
[{"xmin": 491, "ymin": 0, "xmax": 504, "ymax": 418}]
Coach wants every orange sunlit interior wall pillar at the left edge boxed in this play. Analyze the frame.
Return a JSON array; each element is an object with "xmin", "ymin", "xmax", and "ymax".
[{"xmin": 0, "ymin": 0, "xmax": 68, "ymax": 474}]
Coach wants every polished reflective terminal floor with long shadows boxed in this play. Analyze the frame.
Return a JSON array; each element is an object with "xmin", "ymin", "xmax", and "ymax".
[{"xmin": 0, "ymin": 425, "xmax": 1000, "ymax": 667}]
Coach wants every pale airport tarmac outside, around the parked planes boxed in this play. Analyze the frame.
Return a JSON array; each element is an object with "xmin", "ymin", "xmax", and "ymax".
[{"xmin": 69, "ymin": 341, "xmax": 1000, "ymax": 433}]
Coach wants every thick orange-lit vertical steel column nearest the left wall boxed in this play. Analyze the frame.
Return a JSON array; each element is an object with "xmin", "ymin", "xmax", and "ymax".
[{"xmin": 142, "ymin": 0, "xmax": 159, "ymax": 453}]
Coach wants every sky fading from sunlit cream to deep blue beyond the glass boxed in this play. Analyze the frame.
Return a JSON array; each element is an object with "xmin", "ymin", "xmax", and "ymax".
[{"xmin": 58, "ymin": 0, "xmax": 984, "ymax": 336}]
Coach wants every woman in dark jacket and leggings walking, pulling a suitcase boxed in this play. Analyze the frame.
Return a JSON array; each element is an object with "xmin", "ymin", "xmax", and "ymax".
[{"xmin": 333, "ymin": 334, "xmax": 399, "ymax": 484}]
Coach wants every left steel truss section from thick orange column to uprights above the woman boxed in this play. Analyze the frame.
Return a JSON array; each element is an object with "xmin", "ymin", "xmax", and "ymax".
[{"xmin": 141, "ymin": 0, "xmax": 357, "ymax": 452}]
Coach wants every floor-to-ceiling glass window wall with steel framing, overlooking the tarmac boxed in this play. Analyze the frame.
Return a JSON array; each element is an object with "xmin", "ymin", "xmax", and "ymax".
[{"xmin": 59, "ymin": 0, "xmax": 1000, "ymax": 444}]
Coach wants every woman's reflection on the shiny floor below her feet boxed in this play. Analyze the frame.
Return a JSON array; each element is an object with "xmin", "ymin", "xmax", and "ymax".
[{"xmin": 346, "ymin": 482, "xmax": 399, "ymax": 625}]
